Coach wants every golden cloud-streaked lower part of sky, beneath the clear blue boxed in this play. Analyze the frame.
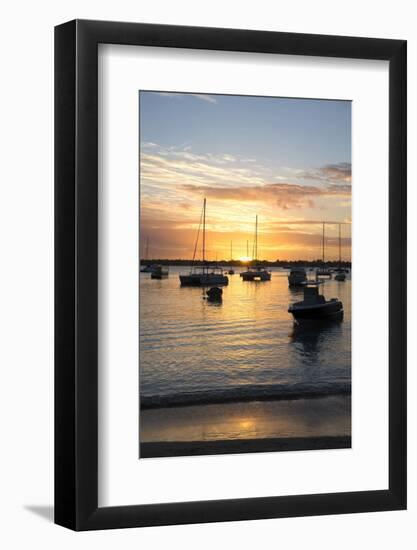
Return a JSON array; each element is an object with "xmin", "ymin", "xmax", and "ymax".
[{"xmin": 140, "ymin": 142, "xmax": 351, "ymax": 259}]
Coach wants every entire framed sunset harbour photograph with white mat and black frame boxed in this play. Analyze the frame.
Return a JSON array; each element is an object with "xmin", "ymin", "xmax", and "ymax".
[{"xmin": 55, "ymin": 20, "xmax": 407, "ymax": 530}]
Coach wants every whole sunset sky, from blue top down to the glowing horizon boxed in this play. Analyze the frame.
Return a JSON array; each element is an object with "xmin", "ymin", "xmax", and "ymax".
[{"xmin": 139, "ymin": 92, "xmax": 351, "ymax": 260}]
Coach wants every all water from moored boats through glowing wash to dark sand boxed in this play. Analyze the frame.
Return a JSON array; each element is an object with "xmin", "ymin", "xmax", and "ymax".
[{"xmin": 139, "ymin": 266, "xmax": 351, "ymax": 452}]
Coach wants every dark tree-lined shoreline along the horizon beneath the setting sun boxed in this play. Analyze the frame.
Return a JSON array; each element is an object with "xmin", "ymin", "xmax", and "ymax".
[{"xmin": 140, "ymin": 258, "xmax": 352, "ymax": 269}]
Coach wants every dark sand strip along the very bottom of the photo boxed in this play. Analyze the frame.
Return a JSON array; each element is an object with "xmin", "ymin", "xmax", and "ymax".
[{"xmin": 140, "ymin": 435, "xmax": 352, "ymax": 458}]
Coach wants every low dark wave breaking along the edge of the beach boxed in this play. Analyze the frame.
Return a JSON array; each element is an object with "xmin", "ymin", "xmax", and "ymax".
[{"xmin": 140, "ymin": 383, "xmax": 351, "ymax": 409}]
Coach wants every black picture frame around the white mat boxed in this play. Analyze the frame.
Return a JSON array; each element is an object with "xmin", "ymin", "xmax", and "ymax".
[{"xmin": 55, "ymin": 20, "xmax": 407, "ymax": 531}]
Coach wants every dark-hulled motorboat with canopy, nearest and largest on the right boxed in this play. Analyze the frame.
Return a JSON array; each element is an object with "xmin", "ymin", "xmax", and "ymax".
[{"xmin": 288, "ymin": 283, "xmax": 343, "ymax": 322}]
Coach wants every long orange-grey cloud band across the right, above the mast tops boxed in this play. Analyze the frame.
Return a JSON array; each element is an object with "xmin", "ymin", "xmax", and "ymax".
[{"xmin": 182, "ymin": 183, "xmax": 351, "ymax": 210}]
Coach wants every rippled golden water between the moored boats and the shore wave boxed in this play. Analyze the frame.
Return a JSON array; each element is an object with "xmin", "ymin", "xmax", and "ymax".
[{"xmin": 140, "ymin": 266, "xmax": 351, "ymax": 406}]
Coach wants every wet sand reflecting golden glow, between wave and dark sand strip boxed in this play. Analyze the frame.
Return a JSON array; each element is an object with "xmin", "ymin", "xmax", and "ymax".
[{"xmin": 141, "ymin": 396, "xmax": 350, "ymax": 442}]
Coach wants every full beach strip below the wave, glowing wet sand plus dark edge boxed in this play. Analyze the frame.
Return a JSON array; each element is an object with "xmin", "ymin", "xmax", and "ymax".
[{"xmin": 140, "ymin": 395, "xmax": 351, "ymax": 458}]
